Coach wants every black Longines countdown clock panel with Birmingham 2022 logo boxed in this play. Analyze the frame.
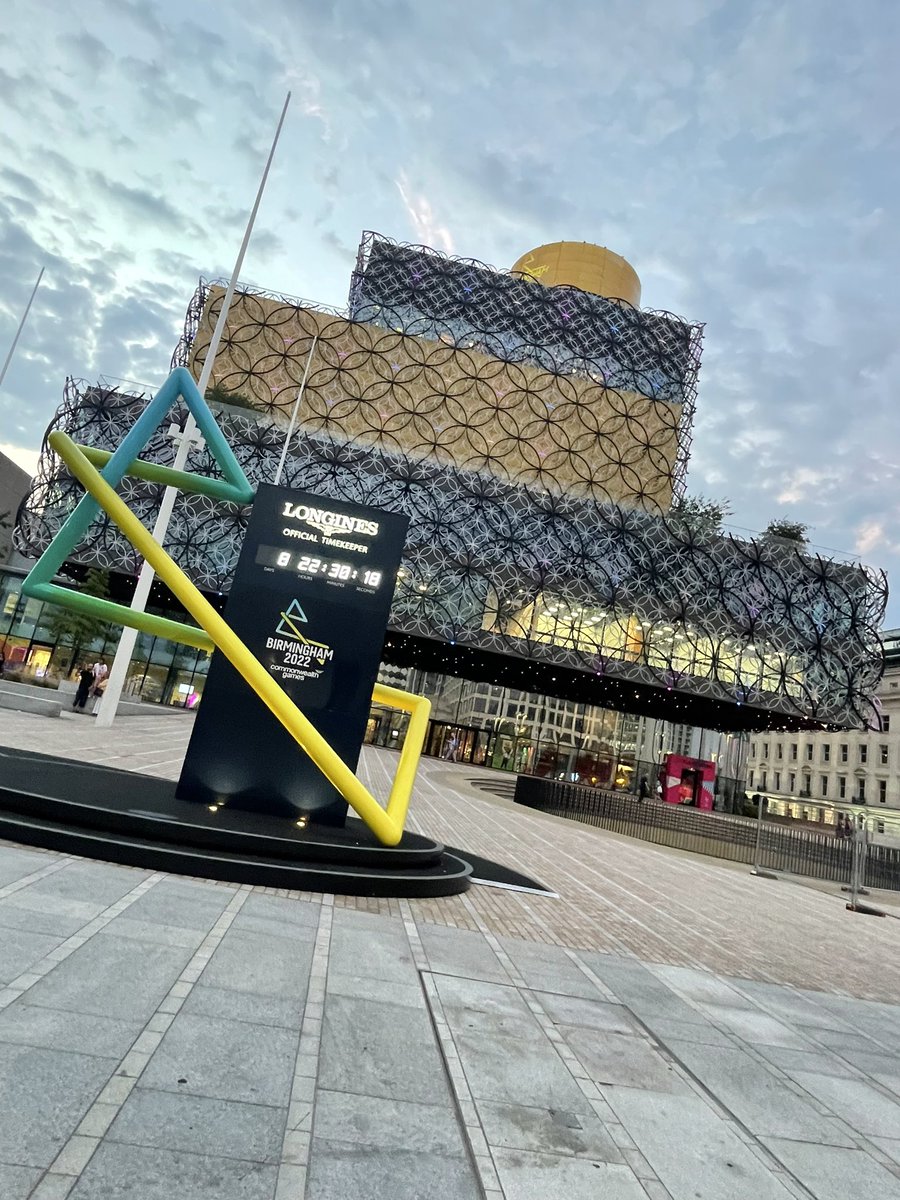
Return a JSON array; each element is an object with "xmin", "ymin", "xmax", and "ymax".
[{"xmin": 176, "ymin": 484, "xmax": 408, "ymax": 824}]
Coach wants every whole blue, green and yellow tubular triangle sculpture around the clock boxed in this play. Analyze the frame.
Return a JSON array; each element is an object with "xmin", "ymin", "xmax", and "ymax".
[{"xmin": 22, "ymin": 367, "xmax": 431, "ymax": 846}]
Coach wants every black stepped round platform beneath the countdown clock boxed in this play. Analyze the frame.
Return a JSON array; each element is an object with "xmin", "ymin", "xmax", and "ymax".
[{"xmin": 0, "ymin": 748, "xmax": 545, "ymax": 896}]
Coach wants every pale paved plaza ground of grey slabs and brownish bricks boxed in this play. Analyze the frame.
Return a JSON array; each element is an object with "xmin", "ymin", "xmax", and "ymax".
[{"xmin": 0, "ymin": 712, "xmax": 900, "ymax": 1200}]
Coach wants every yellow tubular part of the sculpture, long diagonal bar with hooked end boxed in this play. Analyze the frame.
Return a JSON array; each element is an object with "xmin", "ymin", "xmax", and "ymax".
[{"xmin": 48, "ymin": 432, "xmax": 431, "ymax": 846}]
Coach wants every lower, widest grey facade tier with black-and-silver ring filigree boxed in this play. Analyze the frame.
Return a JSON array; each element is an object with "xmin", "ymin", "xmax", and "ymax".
[{"xmin": 18, "ymin": 382, "xmax": 886, "ymax": 727}]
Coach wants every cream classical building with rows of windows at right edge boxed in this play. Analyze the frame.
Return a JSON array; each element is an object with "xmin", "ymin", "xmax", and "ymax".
[{"xmin": 746, "ymin": 629, "xmax": 900, "ymax": 820}]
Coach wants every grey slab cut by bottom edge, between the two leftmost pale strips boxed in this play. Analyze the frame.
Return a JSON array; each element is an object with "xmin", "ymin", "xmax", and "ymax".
[{"xmin": 68, "ymin": 1141, "xmax": 277, "ymax": 1200}]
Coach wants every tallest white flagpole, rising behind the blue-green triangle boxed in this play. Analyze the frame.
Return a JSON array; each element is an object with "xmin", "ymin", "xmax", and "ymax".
[{"xmin": 97, "ymin": 92, "xmax": 290, "ymax": 726}]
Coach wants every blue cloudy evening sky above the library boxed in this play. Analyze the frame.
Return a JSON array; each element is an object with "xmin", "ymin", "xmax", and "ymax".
[{"xmin": 0, "ymin": 0, "xmax": 900, "ymax": 624}]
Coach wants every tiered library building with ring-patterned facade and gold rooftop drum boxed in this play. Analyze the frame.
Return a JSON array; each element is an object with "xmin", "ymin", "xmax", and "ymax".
[{"xmin": 8, "ymin": 233, "xmax": 886, "ymax": 786}]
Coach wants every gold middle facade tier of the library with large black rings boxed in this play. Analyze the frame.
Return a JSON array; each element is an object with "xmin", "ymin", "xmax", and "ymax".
[{"xmin": 191, "ymin": 287, "xmax": 680, "ymax": 511}]
